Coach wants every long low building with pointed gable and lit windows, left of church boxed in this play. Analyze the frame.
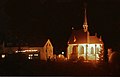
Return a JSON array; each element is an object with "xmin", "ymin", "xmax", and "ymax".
[{"xmin": 3, "ymin": 39, "xmax": 53, "ymax": 60}]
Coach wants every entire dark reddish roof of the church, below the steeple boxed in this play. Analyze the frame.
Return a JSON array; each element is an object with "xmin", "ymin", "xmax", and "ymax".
[{"xmin": 68, "ymin": 29, "xmax": 103, "ymax": 44}]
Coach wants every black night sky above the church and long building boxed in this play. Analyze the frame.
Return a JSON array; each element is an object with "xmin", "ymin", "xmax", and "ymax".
[{"xmin": 0, "ymin": 0, "xmax": 120, "ymax": 50}]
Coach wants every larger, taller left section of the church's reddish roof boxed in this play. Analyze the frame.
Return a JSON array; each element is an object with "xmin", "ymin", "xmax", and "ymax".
[{"xmin": 68, "ymin": 29, "xmax": 87, "ymax": 44}]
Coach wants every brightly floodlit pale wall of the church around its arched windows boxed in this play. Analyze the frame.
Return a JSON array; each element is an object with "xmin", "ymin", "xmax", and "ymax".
[{"xmin": 67, "ymin": 44, "xmax": 102, "ymax": 60}]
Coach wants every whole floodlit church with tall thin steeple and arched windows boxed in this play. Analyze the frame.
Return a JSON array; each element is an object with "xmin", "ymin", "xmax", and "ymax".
[{"xmin": 67, "ymin": 5, "xmax": 104, "ymax": 61}]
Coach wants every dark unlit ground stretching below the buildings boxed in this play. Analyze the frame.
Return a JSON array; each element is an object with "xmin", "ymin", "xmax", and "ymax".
[{"xmin": 0, "ymin": 61, "xmax": 120, "ymax": 76}]
